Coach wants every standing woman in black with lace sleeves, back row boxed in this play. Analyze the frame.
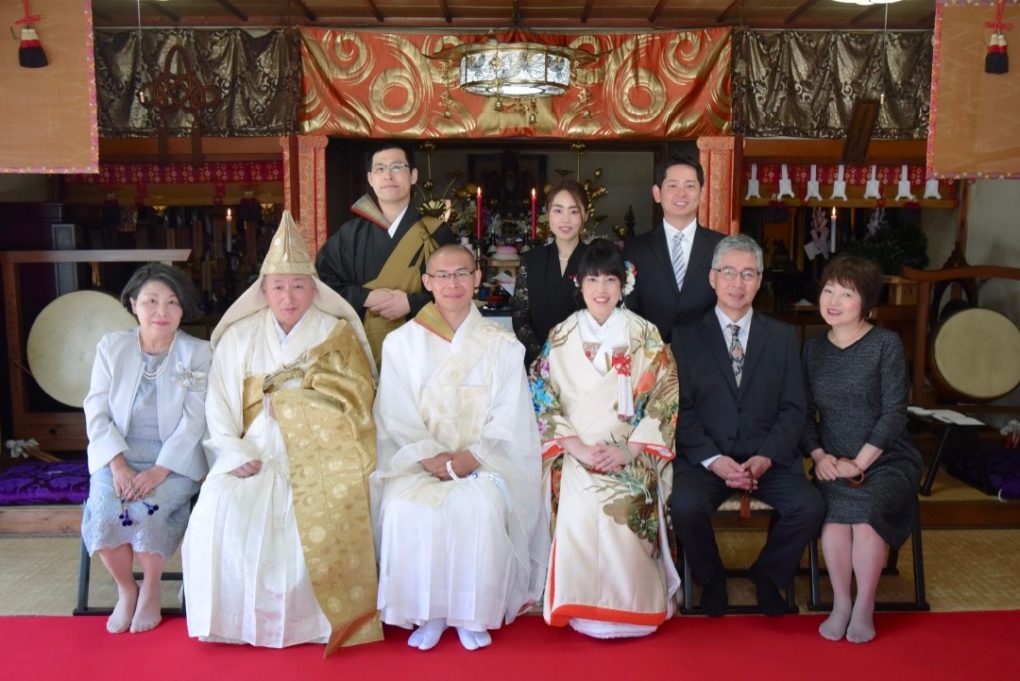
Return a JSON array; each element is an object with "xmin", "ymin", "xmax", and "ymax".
[{"xmin": 511, "ymin": 179, "xmax": 588, "ymax": 367}]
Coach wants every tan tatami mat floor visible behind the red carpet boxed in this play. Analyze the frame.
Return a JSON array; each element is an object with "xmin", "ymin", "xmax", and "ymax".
[{"xmin": 0, "ymin": 529, "xmax": 1020, "ymax": 615}]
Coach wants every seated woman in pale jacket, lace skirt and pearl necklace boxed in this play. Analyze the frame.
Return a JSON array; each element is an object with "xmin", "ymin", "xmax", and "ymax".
[{"xmin": 82, "ymin": 263, "xmax": 211, "ymax": 633}]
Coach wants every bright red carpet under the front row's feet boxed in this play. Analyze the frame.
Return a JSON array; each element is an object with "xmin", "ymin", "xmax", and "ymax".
[{"xmin": 0, "ymin": 611, "xmax": 1020, "ymax": 681}]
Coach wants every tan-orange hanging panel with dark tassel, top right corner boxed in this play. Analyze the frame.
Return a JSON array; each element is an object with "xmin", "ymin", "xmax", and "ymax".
[{"xmin": 927, "ymin": 0, "xmax": 1020, "ymax": 178}]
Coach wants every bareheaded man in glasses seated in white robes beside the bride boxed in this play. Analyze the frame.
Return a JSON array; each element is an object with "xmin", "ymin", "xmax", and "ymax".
[{"xmin": 371, "ymin": 246, "xmax": 549, "ymax": 650}]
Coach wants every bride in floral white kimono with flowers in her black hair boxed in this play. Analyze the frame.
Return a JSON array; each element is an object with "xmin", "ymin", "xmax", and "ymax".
[{"xmin": 531, "ymin": 239, "xmax": 679, "ymax": 638}]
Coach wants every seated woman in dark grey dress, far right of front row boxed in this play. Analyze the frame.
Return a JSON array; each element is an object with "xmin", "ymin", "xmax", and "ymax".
[{"xmin": 801, "ymin": 257, "xmax": 921, "ymax": 643}]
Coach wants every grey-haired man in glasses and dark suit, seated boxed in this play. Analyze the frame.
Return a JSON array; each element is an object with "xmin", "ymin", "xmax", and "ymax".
[{"xmin": 670, "ymin": 234, "xmax": 825, "ymax": 617}]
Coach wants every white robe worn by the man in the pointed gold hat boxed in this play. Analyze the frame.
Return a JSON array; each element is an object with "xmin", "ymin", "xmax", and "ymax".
[{"xmin": 182, "ymin": 307, "xmax": 338, "ymax": 647}]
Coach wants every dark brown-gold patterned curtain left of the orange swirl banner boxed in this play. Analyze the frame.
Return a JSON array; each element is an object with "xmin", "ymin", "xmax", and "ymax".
[{"xmin": 96, "ymin": 29, "xmax": 301, "ymax": 138}]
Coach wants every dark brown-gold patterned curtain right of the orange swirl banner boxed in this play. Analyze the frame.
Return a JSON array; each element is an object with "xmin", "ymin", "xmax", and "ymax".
[{"xmin": 733, "ymin": 31, "xmax": 931, "ymax": 140}]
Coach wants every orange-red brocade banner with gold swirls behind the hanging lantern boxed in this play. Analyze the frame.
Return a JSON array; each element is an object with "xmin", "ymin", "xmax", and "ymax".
[{"xmin": 300, "ymin": 28, "xmax": 730, "ymax": 140}]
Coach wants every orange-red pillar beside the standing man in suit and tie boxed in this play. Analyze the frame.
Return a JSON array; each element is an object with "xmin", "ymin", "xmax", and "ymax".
[{"xmin": 698, "ymin": 137, "xmax": 743, "ymax": 234}]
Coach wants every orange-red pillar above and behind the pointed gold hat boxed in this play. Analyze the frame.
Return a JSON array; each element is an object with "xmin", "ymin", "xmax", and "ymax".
[{"xmin": 281, "ymin": 135, "xmax": 329, "ymax": 249}]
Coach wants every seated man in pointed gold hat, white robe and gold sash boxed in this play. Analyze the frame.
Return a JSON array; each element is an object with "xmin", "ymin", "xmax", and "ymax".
[{"xmin": 182, "ymin": 212, "xmax": 383, "ymax": 654}]
